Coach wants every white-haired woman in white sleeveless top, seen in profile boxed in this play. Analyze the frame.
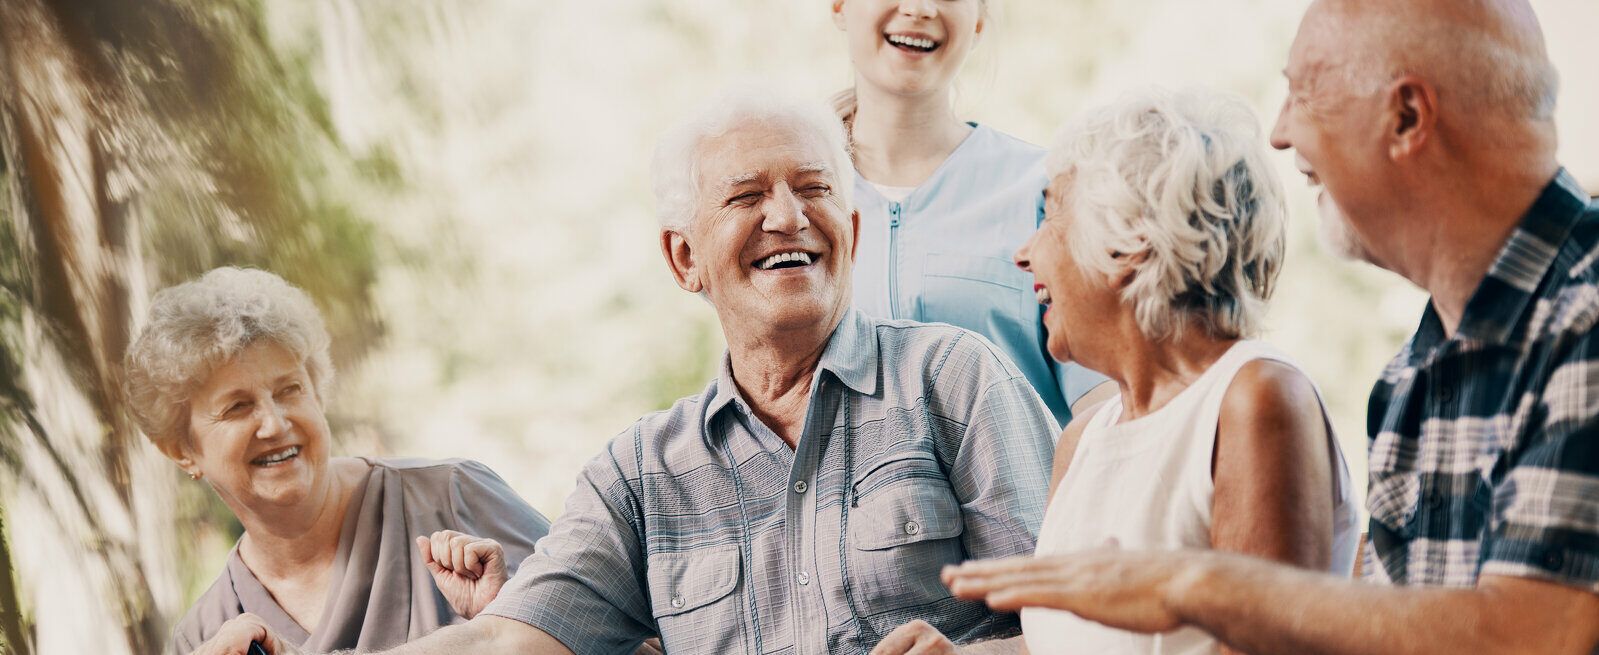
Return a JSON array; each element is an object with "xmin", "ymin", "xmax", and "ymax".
[{"xmin": 947, "ymin": 93, "xmax": 1359, "ymax": 655}]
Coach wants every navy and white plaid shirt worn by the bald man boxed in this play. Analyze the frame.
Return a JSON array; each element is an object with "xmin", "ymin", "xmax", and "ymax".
[{"xmin": 1366, "ymin": 169, "xmax": 1599, "ymax": 593}]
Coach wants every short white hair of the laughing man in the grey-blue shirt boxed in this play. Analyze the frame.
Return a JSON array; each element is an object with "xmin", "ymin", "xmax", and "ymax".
[{"xmin": 651, "ymin": 83, "xmax": 855, "ymax": 230}]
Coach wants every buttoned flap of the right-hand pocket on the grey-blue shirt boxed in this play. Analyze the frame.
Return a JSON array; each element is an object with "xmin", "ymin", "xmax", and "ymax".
[{"xmin": 849, "ymin": 478, "xmax": 966, "ymax": 551}]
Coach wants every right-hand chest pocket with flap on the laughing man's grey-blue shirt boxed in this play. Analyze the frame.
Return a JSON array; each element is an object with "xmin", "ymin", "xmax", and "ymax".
[{"xmin": 844, "ymin": 454, "xmax": 966, "ymax": 637}]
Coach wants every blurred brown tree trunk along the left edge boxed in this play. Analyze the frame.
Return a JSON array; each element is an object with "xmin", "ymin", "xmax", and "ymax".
[{"xmin": 0, "ymin": 0, "xmax": 171, "ymax": 653}]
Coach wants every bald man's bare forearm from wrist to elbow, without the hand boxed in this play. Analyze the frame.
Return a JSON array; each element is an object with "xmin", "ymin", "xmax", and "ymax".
[{"xmin": 1170, "ymin": 553, "xmax": 1591, "ymax": 655}]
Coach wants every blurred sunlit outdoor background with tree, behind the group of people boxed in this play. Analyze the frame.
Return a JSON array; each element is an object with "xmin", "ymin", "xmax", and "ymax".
[{"xmin": 0, "ymin": 0, "xmax": 1599, "ymax": 653}]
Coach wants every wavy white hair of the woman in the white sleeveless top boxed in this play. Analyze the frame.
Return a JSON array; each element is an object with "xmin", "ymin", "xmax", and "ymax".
[{"xmin": 1046, "ymin": 91, "xmax": 1286, "ymax": 339}]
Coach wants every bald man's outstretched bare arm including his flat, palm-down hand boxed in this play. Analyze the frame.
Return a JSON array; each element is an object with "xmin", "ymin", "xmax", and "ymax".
[{"xmin": 943, "ymin": 548, "xmax": 1599, "ymax": 655}]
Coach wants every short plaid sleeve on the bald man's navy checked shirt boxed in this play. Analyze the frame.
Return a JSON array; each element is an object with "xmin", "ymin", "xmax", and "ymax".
[{"xmin": 1482, "ymin": 331, "xmax": 1599, "ymax": 593}]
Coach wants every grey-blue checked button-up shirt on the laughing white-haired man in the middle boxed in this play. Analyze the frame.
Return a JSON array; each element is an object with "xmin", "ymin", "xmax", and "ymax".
[{"xmin": 486, "ymin": 310, "xmax": 1057, "ymax": 655}]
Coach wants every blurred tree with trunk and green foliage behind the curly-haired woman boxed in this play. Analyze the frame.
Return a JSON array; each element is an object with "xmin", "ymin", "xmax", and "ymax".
[{"xmin": 0, "ymin": 0, "xmax": 383, "ymax": 653}]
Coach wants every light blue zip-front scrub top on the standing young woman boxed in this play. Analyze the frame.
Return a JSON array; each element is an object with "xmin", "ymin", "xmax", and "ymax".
[{"xmin": 854, "ymin": 123, "xmax": 1105, "ymax": 425}]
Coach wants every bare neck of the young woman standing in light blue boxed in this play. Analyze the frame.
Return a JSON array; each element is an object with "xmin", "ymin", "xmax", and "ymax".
[{"xmin": 851, "ymin": 85, "xmax": 972, "ymax": 187}]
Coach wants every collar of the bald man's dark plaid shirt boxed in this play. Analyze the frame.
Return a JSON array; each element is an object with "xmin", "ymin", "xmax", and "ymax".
[{"xmin": 1458, "ymin": 168, "xmax": 1588, "ymax": 343}]
